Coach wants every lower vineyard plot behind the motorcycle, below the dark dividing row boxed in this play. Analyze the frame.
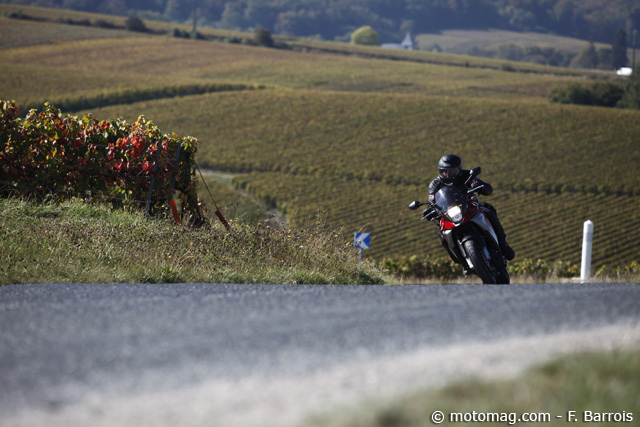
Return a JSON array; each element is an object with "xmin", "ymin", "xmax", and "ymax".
[{"xmin": 232, "ymin": 173, "xmax": 640, "ymax": 265}]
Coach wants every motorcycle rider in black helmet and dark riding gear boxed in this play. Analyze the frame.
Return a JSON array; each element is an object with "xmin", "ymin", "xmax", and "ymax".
[{"xmin": 426, "ymin": 154, "xmax": 516, "ymax": 261}]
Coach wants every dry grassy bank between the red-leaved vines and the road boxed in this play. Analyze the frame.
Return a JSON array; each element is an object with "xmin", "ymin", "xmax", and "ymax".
[{"xmin": 0, "ymin": 199, "xmax": 390, "ymax": 285}]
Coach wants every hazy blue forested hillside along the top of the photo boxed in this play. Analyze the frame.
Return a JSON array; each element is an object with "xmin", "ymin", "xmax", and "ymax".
[{"xmin": 5, "ymin": 0, "xmax": 640, "ymax": 43}]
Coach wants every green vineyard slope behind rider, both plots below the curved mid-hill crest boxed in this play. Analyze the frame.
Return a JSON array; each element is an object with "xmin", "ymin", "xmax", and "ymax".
[{"xmin": 90, "ymin": 91, "xmax": 640, "ymax": 265}]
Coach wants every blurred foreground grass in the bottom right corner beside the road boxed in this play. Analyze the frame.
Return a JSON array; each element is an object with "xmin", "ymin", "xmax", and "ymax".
[{"xmin": 305, "ymin": 349, "xmax": 640, "ymax": 427}]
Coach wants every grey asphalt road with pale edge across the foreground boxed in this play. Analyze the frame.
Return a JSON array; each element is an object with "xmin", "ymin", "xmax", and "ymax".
[{"xmin": 0, "ymin": 284, "xmax": 640, "ymax": 425}]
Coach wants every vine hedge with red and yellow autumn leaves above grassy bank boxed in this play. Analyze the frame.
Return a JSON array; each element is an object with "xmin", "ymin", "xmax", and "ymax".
[{"xmin": 0, "ymin": 101, "xmax": 197, "ymax": 214}]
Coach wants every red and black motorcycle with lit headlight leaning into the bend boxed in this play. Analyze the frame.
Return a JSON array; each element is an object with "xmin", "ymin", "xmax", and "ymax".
[{"xmin": 409, "ymin": 167, "xmax": 510, "ymax": 285}]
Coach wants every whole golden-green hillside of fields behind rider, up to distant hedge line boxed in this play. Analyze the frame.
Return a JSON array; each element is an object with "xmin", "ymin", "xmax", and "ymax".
[{"xmin": 0, "ymin": 5, "xmax": 640, "ymax": 266}]
